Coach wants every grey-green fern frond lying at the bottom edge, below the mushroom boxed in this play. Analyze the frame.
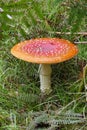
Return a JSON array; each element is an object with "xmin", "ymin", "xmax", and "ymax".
[{"xmin": 28, "ymin": 111, "xmax": 86, "ymax": 130}]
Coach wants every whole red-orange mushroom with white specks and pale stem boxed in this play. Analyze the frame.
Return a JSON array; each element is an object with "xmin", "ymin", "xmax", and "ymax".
[{"xmin": 11, "ymin": 38, "xmax": 78, "ymax": 94}]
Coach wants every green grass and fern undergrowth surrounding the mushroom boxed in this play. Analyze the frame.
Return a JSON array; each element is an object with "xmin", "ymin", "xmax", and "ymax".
[{"xmin": 0, "ymin": 0, "xmax": 87, "ymax": 130}]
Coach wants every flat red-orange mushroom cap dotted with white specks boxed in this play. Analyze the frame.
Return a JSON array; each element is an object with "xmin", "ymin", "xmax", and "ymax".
[{"xmin": 11, "ymin": 38, "xmax": 78, "ymax": 64}]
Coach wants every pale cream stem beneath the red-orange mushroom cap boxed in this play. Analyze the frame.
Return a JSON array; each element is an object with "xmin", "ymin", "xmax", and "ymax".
[{"xmin": 39, "ymin": 64, "xmax": 52, "ymax": 94}]
